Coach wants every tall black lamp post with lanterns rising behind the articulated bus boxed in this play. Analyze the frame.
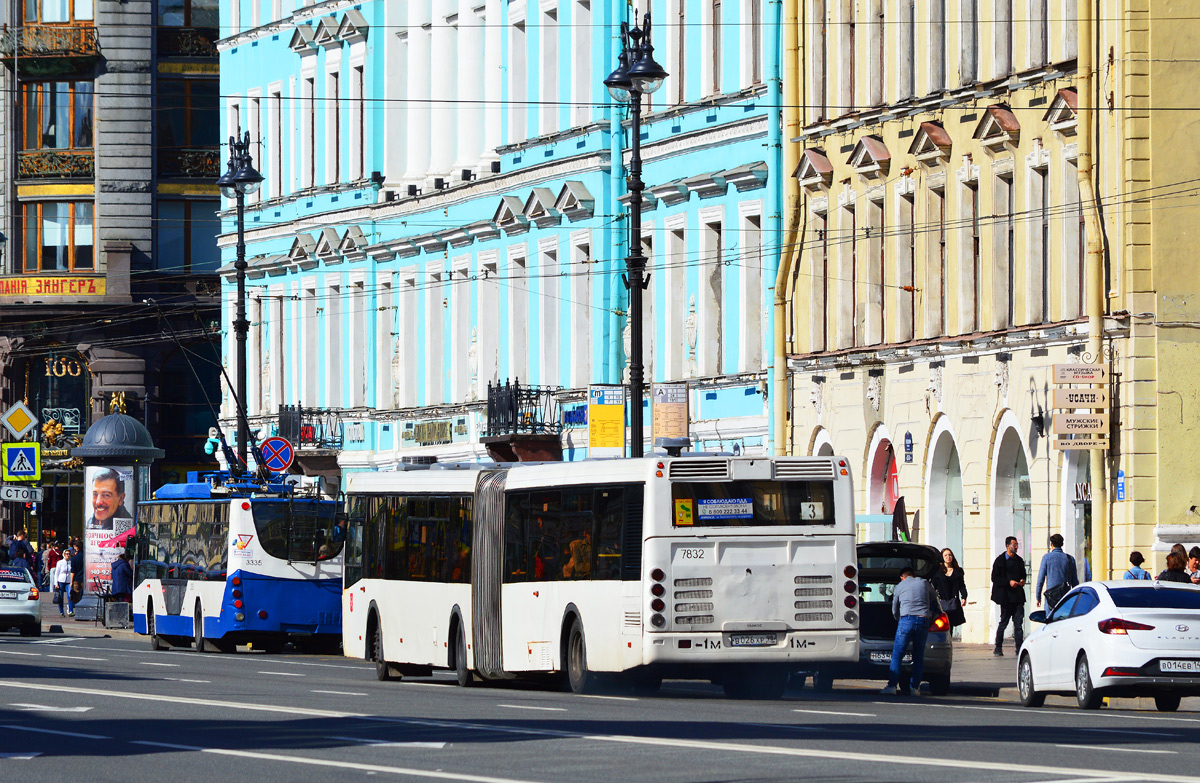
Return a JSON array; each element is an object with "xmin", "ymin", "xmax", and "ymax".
[{"xmin": 604, "ymin": 11, "xmax": 667, "ymax": 458}]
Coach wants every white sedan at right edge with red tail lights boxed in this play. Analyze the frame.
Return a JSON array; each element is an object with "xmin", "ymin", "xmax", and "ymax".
[{"xmin": 1016, "ymin": 581, "xmax": 1200, "ymax": 712}]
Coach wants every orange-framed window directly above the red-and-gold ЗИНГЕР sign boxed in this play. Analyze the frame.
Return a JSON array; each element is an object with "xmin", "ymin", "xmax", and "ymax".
[{"xmin": 20, "ymin": 202, "xmax": 96, "ymax": 271}]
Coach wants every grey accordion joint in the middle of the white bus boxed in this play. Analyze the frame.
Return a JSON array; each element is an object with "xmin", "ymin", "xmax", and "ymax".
[{"xmin": 470, "ymin": 471, "xmax": 508, "ymax": 680}]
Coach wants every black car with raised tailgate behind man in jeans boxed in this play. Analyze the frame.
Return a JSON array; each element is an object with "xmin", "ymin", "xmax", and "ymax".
[{"xmin": 811, "ymin": 542, "xmax": 954, "ymax": 695}]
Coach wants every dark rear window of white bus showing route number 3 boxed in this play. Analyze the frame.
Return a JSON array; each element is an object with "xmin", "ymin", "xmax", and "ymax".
[{"xmin": 671, "ymin": 482, "xmax": 834, "ymax": 527}]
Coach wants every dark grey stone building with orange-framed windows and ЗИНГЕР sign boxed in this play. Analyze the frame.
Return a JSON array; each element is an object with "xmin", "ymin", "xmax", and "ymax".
[{"xmin": 0, "ymin": 0, "xmax": 222, "ymax": 538}]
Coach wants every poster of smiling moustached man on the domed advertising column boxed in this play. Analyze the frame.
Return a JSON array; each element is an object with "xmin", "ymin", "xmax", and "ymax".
[{"xmin": 83, "ymin": 467, "xmax": 137, "ymax": 592}]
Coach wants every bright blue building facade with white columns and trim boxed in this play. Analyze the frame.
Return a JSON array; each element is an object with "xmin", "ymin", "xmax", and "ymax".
[{"xmin": 220, "ymin": 0, "xmax": 781, "ymax": 478}]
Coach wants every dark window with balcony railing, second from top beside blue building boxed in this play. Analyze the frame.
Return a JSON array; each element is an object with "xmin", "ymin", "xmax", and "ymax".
[{"xmin": 155, "ymin": 79, "xmax": 221, "ymax": 179}]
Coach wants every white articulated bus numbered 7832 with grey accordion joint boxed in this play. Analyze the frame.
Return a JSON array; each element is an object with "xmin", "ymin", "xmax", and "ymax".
[{"xmin": 342, "ymin": 455, "xmax": 859, "ymax": 697}]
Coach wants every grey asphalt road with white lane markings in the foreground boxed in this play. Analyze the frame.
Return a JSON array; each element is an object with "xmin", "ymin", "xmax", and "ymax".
[{"xmin": 0, "ymin": 629, "xmax": 1200, "ymax": 783}]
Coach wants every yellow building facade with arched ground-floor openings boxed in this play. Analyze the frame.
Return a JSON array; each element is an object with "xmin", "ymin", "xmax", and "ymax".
[{"xmin": 781, "ymin": 0, "xmax": 1200, "ymax": 641}]
